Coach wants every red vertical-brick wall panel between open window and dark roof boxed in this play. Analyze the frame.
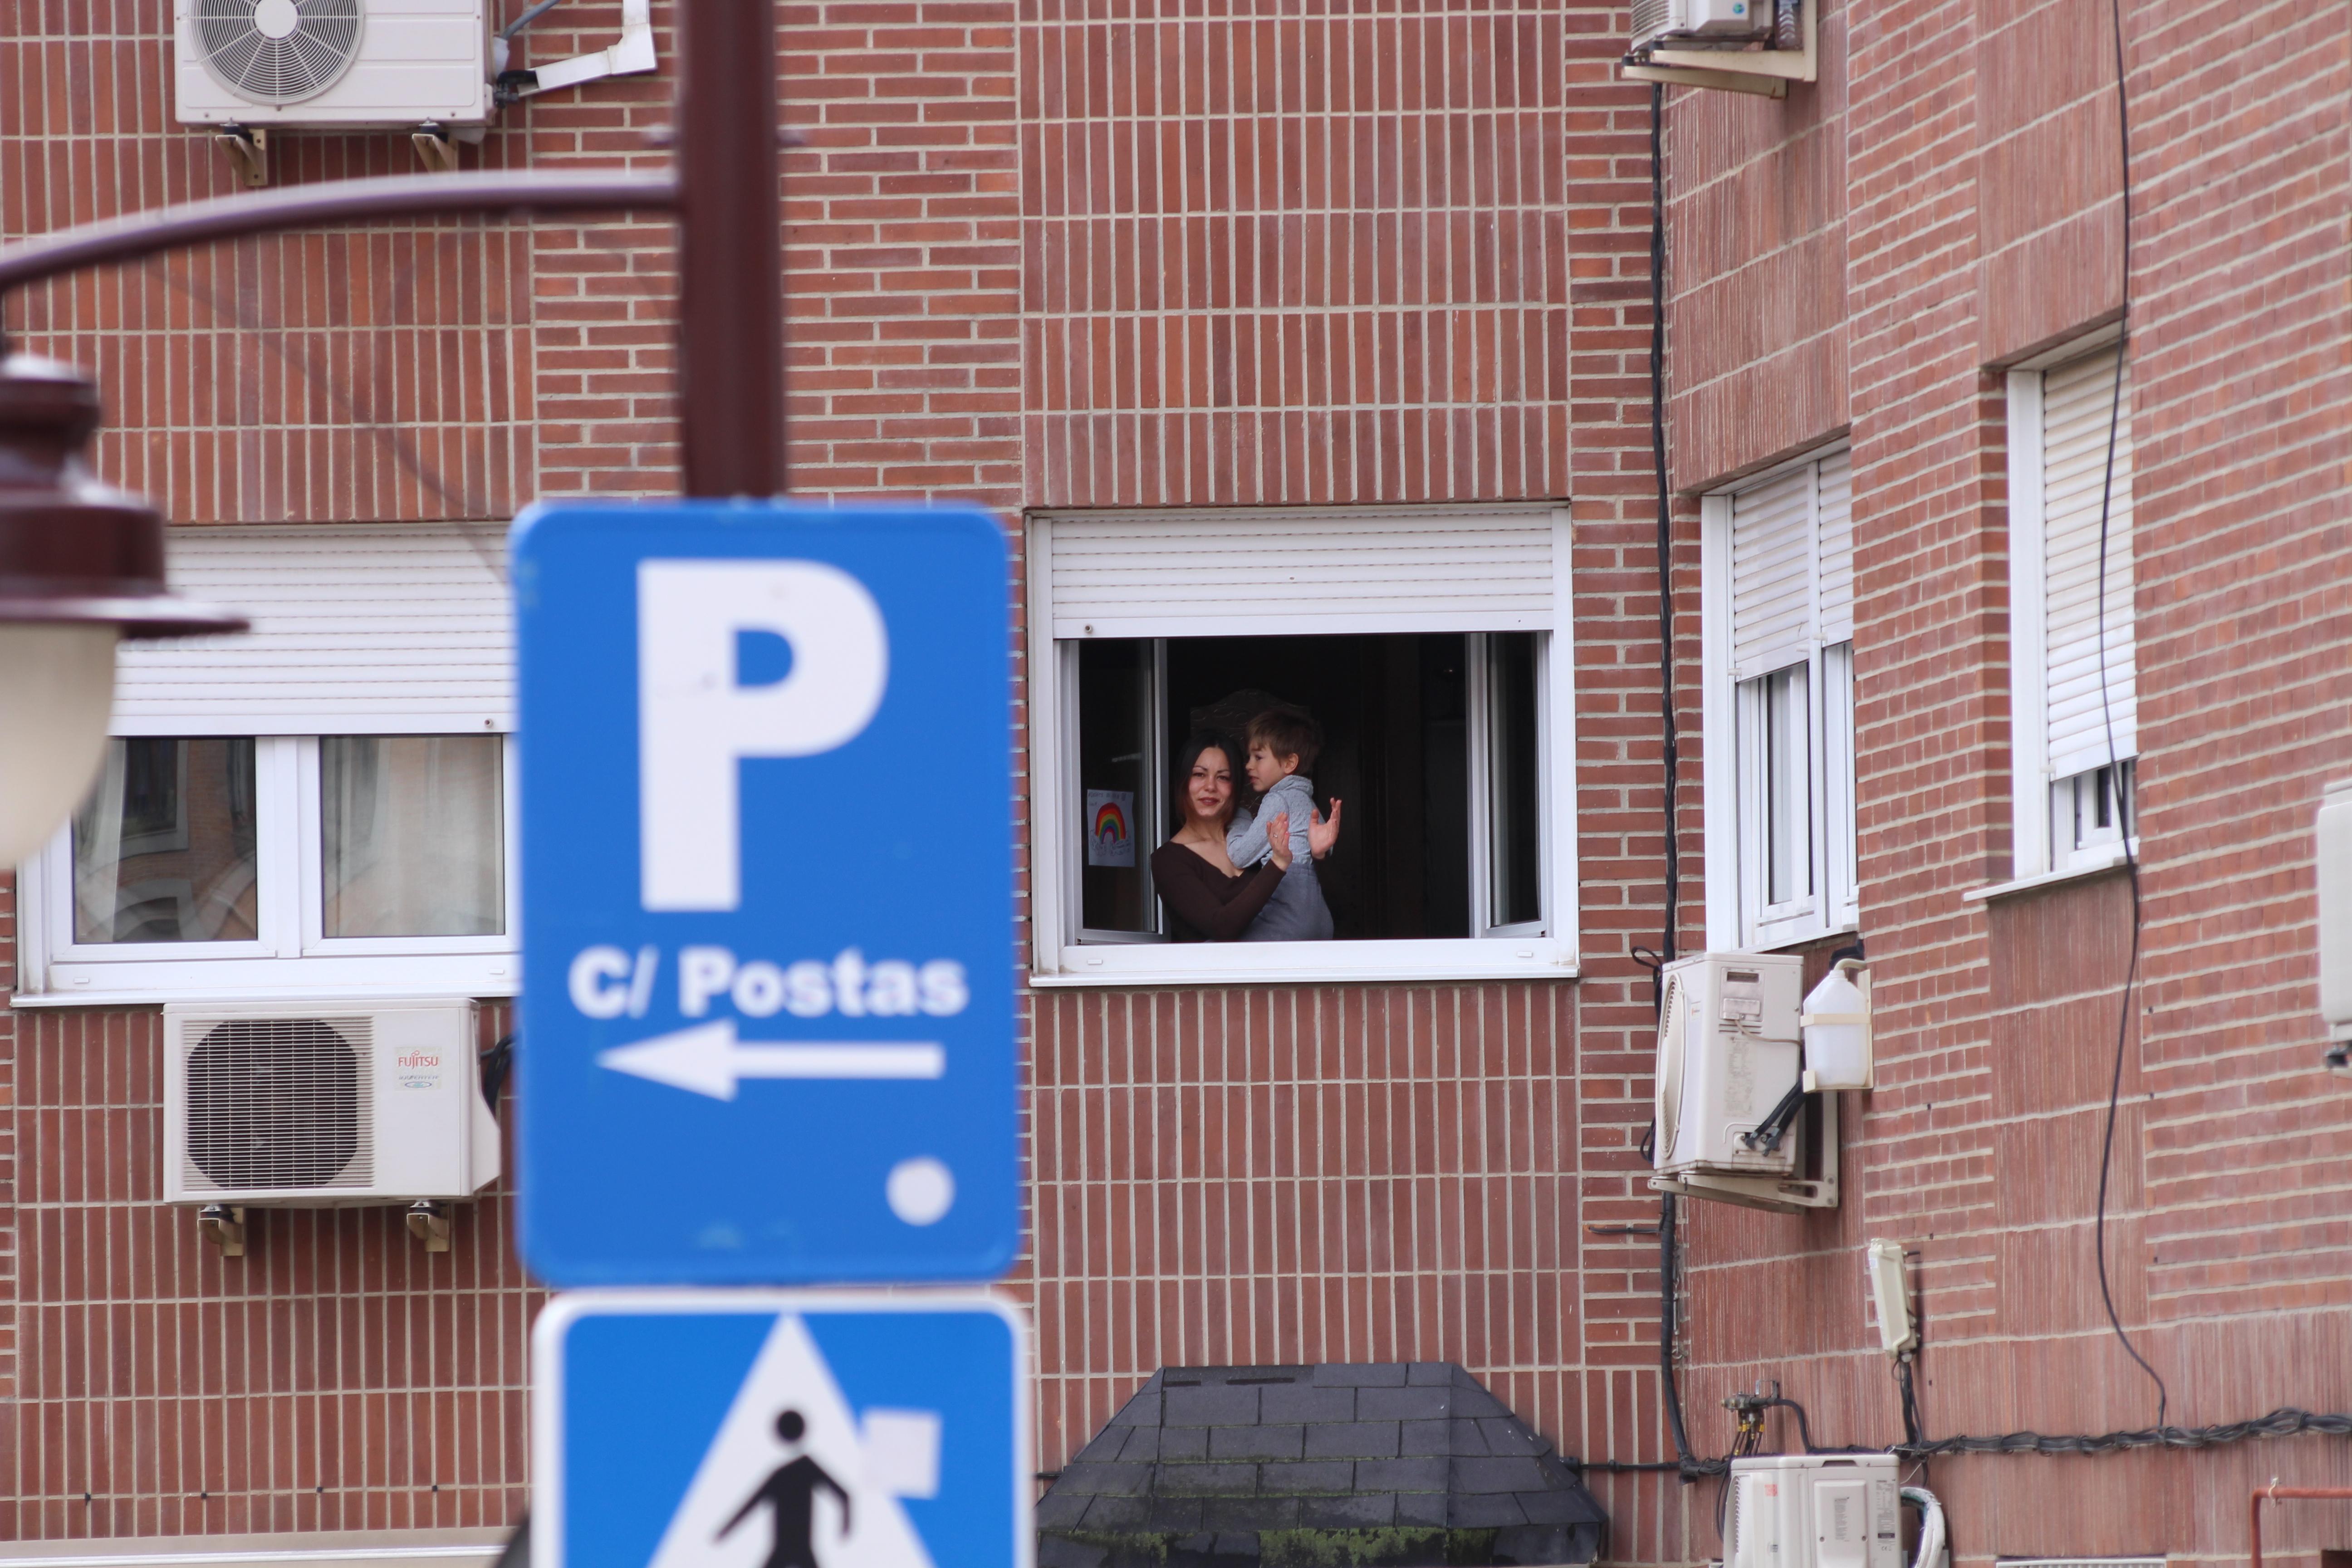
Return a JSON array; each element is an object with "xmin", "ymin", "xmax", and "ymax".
[{"xmin": 1028, "ymin": 985, "xmax": 1581, "ymax": 1469}]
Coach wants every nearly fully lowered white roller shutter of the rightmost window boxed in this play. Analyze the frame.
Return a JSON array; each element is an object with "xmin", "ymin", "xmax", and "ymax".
[{"xmin": 2042, "ymin": 348, "xmax": 2138, "ymax": 778}]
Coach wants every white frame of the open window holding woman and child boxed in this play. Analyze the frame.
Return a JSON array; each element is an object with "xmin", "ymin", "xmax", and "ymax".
[{"xmin": 1028, "ymin": 505, "xmax": 1578, "ymax": 987}]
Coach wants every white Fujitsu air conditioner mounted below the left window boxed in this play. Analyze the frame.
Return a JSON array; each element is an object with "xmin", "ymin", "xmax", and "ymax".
[{"xmin": 162, "ymin": 1001, "xmax": 499, "ymax": 1208}]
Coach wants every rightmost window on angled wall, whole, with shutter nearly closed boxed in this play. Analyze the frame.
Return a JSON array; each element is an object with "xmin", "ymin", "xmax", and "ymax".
[{"xmin": 2009, "ymin": 346, "xmax": 2138, "ymax": 877}]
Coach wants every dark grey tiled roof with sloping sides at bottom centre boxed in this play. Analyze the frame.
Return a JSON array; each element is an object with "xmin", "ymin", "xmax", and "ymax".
[{"xmin": 1037, "ymin": 1361, "xmax": 1609, "ymax": 1568}]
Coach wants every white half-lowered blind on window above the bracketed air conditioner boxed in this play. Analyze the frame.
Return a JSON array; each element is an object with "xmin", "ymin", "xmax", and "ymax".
[{"xmin": 1731, "ymin": 451, "xmax": 1853, "ymax": 682}]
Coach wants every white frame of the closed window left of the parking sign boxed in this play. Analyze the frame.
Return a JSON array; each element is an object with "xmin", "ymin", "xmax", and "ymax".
[{"xmin": 14, "ymin": 733, "xmax": 522, "ymax": 1006}]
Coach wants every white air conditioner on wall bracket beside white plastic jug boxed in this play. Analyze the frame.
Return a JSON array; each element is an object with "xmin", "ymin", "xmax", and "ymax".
[{"xmin": 1651, "ymin": 952, "xmax": 1804, "ymax": 1176}]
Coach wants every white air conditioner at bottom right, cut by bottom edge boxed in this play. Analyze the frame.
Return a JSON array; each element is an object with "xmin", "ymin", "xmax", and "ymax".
[{"xmin": 1724, "ymin": 1453, "xmax": 1903, "ymax": 1568}]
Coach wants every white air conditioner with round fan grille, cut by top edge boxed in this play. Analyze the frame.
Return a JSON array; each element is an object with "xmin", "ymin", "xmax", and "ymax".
[{"xmin": 174, "ymin": 0, "xmax": 496, "ymax": 132}]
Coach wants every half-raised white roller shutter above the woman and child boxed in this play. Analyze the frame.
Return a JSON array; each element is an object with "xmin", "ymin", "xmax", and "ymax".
[{"xmin": 1033, "ymin": 508, "xmax": 1564, "ymax": 637}]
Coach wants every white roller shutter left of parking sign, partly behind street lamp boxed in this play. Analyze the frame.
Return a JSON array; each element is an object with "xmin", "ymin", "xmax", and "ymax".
[{"xmin": 115, "ymin": 524, "xmax": 515, "ymax": 736}]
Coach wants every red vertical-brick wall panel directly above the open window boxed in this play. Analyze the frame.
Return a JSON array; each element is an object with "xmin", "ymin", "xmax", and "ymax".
[{"xmin": 1021, "ymin": 0, "xmax": 1569, "ymax": 505}]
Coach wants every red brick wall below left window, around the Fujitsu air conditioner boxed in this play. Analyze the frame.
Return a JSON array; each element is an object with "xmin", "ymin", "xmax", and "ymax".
[{"xmin": 0, "ymin": 1009, "xmax": 541, "ymax": 1540}]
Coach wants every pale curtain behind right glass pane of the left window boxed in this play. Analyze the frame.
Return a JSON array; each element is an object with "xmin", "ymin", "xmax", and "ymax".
[{"xmin": 318, "ymin": 736, "xmax": 506, "ymax": 938}]
